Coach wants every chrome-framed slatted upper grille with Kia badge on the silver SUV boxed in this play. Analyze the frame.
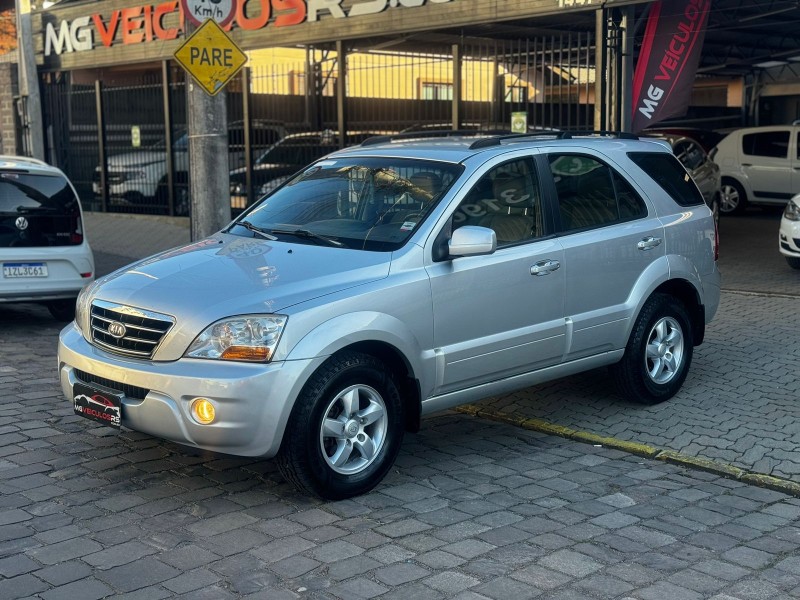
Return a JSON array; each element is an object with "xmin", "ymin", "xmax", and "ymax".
[{"xmin": 91, "ymin": 300, "xmax": 175, "ymax": 359}]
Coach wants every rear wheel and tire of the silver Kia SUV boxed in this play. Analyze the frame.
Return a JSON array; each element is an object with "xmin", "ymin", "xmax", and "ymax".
[{"xmin": 611, "ymin": 294, "xmax": 694, "ymax": 404}]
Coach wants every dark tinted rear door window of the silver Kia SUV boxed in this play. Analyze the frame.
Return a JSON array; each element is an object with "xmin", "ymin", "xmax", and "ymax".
[{"xmin": 549, "ymin": 154, "xmax": 647, "ymax": 231}]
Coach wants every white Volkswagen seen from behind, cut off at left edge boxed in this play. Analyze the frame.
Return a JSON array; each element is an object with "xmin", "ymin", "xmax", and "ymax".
[{"xmin": 0, "ymin": 156, "xmax": 95, "ymax": 321}]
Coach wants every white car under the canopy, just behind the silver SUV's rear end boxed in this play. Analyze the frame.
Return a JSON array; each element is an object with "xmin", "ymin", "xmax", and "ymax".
[{"xmin": 711, "ymin": 123, "xmax": 800, "ymax": 214}]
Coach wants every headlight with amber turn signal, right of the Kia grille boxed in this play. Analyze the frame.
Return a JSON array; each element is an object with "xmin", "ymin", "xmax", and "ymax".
[{"xmin": 185, "ymin": 315, "xmax": 288, "ymax": 362}]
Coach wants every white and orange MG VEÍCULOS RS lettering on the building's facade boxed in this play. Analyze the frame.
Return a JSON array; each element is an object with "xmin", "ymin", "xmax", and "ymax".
[{"xmin": 44, "ymin": 0, "xmax": 453, "ymax": 56}]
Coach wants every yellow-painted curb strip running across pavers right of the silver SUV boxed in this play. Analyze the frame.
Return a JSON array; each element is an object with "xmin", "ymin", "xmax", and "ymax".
[{"xmin": 455, "ymin": 404, "xmax": 800, "ymax": 498}]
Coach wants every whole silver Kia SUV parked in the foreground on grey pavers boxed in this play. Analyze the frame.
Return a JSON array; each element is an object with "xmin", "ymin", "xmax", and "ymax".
[{"xmin": 58, "ymin": 134, "xmax": 720, "ymax": 498}]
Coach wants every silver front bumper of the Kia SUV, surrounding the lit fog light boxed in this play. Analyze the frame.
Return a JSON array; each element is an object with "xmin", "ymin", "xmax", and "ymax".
[{"xmin": 58, "ymin": 323, "xmax": 324, "ymax": 457}]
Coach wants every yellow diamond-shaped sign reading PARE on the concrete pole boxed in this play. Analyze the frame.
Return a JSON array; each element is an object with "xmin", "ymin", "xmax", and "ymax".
[{"xmin": 175, "ymin": 19, "xmax": 247, "ymax": 96}]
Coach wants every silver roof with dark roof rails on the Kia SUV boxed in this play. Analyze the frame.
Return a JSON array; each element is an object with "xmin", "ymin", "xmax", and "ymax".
[{"xmin": 331, "ymin": 134, "xmax": 670, "ymax": 163}]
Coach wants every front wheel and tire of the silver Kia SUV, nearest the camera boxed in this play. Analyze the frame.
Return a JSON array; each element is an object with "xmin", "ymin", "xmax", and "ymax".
[{"xmin": 277, "ymin": 352, "xmax": 404, "ymax": 500}]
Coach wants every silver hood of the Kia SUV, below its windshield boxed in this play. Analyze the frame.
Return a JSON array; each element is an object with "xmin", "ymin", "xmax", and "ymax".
[{"xmin": 90, "ymin": 233, "xmax": 391, "ymax": 360}]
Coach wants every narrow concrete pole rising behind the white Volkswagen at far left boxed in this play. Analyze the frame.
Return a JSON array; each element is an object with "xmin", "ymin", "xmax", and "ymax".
[{"xmin": 15, "ymin": 0, "xmax": 45, "ymax": 160}]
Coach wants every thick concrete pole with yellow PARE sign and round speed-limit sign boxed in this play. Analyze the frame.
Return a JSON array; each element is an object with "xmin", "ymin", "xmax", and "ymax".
[{"xmin": 175, "ymin": 0, "xmax": 247, "ymax": 240}]
